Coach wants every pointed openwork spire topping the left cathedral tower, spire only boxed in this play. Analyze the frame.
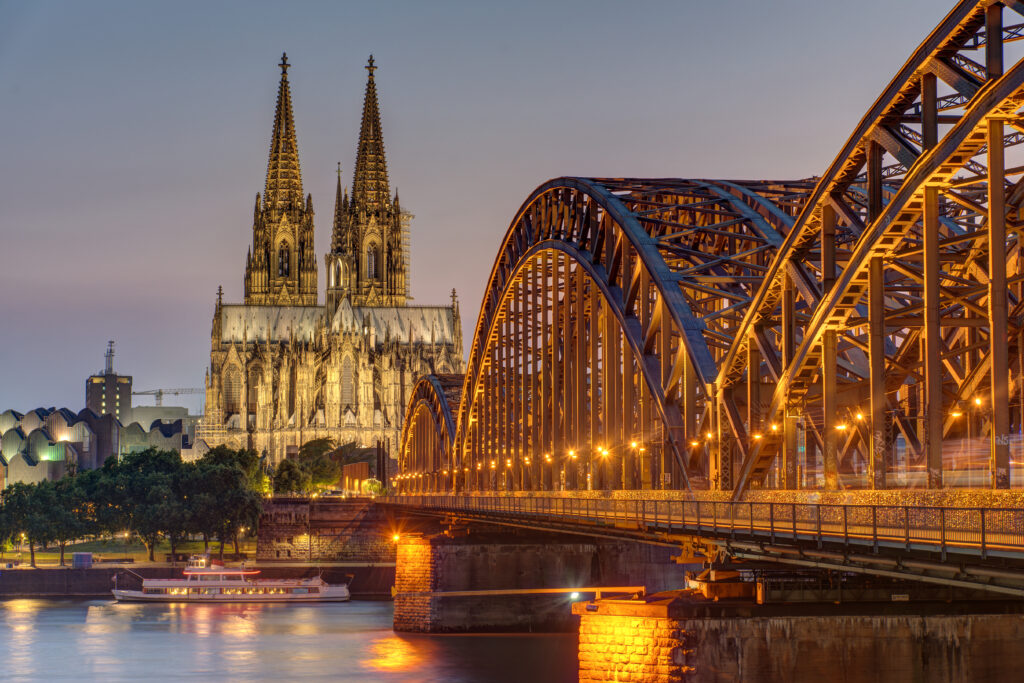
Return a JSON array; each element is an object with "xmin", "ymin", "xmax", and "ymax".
[{"xmin": 263, "ymin": 53, "xmax": 302, "ymax": 210}]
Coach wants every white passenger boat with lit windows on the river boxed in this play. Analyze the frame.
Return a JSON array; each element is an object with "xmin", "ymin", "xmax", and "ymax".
[{"xmin": 113, "ymin": 555, "xmax": 349, "ymax": 602}]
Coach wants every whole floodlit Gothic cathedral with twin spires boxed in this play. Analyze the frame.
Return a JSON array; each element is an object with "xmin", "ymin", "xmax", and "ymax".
[{"xmin": 198, "ymin": 56, "xmax": 463, "ymax": 463}]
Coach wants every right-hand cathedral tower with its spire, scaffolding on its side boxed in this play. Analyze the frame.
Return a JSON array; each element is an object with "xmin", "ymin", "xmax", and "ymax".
[{"xmin": 327, "ymin": 55, "xmax": 412, "ymax": 313}]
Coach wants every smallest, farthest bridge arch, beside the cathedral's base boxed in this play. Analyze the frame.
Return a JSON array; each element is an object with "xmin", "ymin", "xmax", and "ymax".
[{"xmin": 397, "ymin": 375, "xmax": 464, "ymax": 492}]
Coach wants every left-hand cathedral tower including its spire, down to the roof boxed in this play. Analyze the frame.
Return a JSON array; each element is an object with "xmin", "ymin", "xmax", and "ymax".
[{"xmin": 245, "ymin": 54, "xmax": 316, "ymax": 306}]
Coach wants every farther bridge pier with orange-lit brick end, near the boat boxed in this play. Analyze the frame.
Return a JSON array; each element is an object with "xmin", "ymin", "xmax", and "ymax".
[{"xmin": 394, "ymin": 528, "xmax": 684, "ymax": 633}]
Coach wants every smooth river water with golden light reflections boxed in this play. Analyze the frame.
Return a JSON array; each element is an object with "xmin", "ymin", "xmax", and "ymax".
[{"xmin": 0, "ymin": 599, "xmax": 577, "ymax": 683}]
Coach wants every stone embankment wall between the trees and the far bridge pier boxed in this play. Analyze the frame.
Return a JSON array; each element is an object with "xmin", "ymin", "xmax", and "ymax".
[{"xmin": 256, "ymin": 498, "xmax": 395, "ymax": 562}]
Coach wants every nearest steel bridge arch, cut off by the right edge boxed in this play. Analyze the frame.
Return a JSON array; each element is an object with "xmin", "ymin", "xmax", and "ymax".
[{"xmin": 718, "ymin": 2, "xmax": 1024, "ymax": 496}]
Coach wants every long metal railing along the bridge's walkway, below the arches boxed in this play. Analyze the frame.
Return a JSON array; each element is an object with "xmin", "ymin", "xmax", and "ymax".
[{"xmin": 381, "ymin": 496, "xmax": 1024, "ymax": 558}]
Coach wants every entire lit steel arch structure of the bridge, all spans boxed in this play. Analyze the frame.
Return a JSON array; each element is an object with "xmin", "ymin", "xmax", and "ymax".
[{"xmin": 397, "ymin": 0, "xmax": 1024, "ymax": 498}]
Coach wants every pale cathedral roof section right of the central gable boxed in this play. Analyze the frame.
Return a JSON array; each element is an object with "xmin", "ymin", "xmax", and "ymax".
[{"xmin": 331, "ymin": 299, "xmax": 456, "ymax": 344}]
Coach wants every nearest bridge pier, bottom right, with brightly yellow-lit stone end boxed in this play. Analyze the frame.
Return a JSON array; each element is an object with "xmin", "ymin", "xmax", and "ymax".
[{"xmin": 572, "ymin": 591, "xmax": 1024, "ymax": 683}]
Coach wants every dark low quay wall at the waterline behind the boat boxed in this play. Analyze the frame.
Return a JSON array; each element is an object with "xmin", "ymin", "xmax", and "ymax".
[{"xmin": 0, "ymin": 562, "xmax": 394, "ymax": 600}]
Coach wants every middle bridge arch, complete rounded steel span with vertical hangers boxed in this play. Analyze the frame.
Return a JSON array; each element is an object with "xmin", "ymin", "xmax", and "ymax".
[{"xmin": 440, "ymin": 178, "xmax": 813, "ymax": 489}]
